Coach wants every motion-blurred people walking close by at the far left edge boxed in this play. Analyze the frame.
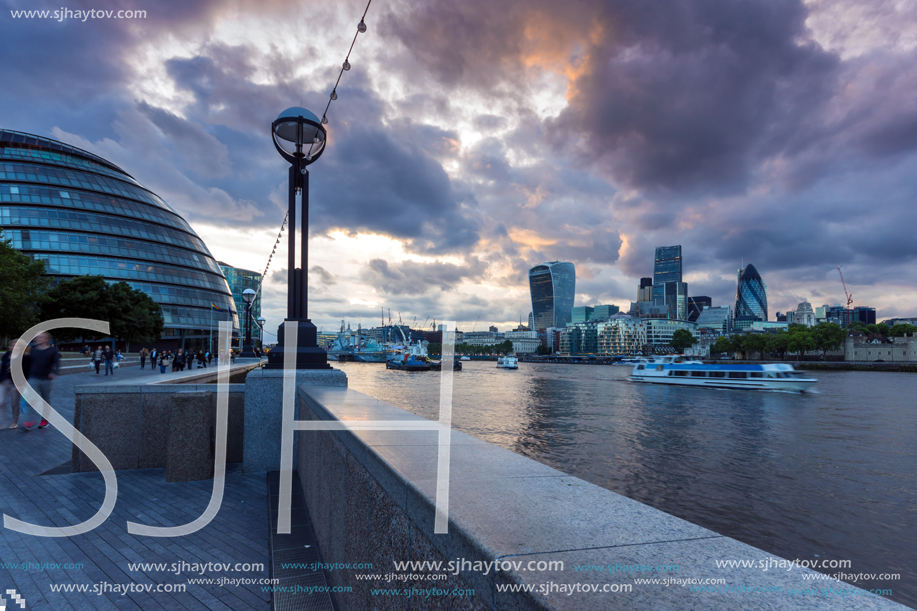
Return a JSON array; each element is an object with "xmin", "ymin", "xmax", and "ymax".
[{"xmin": 0, "ymin": 333, "xmax": 61, "ymax": 430}]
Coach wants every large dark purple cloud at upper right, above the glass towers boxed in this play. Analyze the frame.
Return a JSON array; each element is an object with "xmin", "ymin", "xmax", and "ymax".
[{"xmin": 552, "ymin": 0, "xmax": 839, "ymax": 192}]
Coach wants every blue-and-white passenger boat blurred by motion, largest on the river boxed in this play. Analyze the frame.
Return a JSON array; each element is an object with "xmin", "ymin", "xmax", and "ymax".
[{"xmin": 631, "ymin": 355, "xmax": 817, "ymax": 392}]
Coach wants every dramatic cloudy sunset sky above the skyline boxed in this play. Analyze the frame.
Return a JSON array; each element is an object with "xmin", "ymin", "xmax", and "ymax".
[{"xmin": 0, "ymin": 0, "xmax": 917, "ymax": 330}]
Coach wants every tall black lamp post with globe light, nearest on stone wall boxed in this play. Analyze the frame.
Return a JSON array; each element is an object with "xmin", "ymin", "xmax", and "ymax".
[{"xmin": 267, "ymin": 106, "xmax": 331, "ymax": 369}]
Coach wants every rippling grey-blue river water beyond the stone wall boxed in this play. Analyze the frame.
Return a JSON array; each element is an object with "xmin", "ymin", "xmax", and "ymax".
[{"xmin": 334, "ymin": 361, "xmax": 917, "ymax": 607}]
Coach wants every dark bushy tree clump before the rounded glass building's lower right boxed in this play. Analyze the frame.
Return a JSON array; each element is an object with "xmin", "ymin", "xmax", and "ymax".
[{"xmin": 41, "ymin": 276, "xmax": 164, "ymax": 350}]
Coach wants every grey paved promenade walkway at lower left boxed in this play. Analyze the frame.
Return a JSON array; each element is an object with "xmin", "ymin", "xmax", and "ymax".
[{"xmin": 0, "ymin": 366, "xmax": 270, "ymax": 611}]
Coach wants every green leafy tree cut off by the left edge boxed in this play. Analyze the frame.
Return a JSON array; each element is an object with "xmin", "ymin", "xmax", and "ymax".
[{"xmin": 0, "ymin": 232, "xmax": 48, "ymax": 346}]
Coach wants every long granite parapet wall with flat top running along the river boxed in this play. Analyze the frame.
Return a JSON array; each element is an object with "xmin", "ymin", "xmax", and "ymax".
[{"xmin": 294, "ymin": 386, "xmax": 906, "ymax": 611}]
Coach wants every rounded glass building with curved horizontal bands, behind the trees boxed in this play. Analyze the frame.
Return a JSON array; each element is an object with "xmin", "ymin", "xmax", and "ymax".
[{"xmin": 0, "ymin": 130, "xmax": 239, "ymax": 350}]
